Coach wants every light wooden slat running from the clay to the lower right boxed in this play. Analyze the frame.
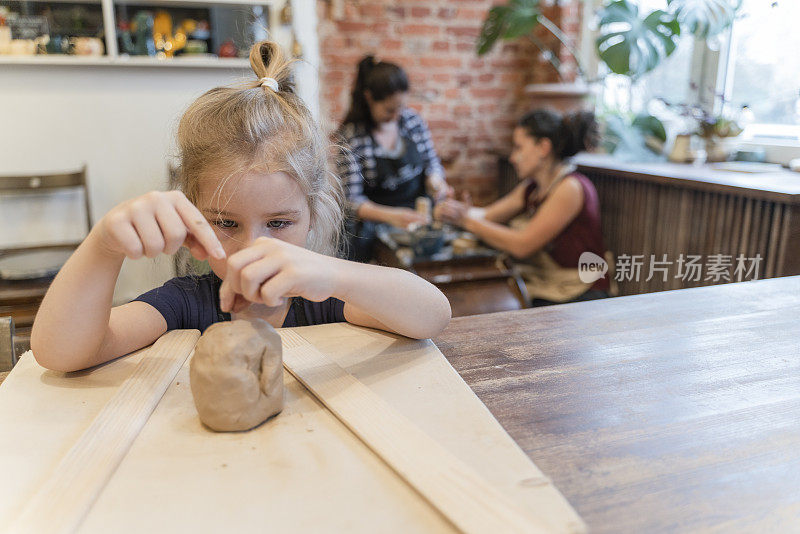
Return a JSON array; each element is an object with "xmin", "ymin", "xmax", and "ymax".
[{"xmin": 281, "ymin": 331, "xmax": 576, "ymax": 534}]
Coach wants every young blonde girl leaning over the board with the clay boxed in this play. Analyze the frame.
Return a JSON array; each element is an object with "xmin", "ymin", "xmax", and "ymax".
[{"xmin": 31, "ymin": 42, "xmax": 450, "ymax": 371}]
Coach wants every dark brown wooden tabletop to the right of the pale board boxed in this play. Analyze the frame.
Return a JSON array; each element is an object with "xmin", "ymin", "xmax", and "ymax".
[{"xmin": 434, "ymin": 277, "xmax": 800, "ymax": 533}]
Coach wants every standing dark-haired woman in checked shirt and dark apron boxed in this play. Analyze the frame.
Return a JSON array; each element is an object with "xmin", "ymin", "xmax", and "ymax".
[{"xmin": 339, "ymin": 56, "xmax": 451, "ymax": 261}]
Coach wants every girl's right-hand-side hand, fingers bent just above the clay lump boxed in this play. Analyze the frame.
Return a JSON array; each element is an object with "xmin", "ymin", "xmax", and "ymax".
[{"xmin": 219, "ymin": 237, "xmax": 336, "ymax": 313}]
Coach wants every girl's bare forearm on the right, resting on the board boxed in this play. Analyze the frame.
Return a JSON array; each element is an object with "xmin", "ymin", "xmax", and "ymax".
[{"xmin": 333, "ymin": 260, "xmax": 451, "ymax": 339}]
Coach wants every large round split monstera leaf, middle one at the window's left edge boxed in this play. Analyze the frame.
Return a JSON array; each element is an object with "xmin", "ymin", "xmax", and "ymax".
[{"xmin": 596, "ymin": 0, "xmax": 681, "ymax": 78}]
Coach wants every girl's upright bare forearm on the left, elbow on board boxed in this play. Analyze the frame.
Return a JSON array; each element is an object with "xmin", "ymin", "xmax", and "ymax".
[{"xmin": 31, "ymin": 233, "xmax": 124, "ymax": 371}]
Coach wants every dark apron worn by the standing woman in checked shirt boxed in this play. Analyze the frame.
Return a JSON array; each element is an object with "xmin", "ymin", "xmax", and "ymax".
[{"xmin": 346, "ymin": 136, "xmax": 426, "ymax": 263}]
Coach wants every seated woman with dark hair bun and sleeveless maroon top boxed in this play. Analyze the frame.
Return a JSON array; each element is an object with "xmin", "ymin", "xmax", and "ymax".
[{"xmin": 435, "ymin": 110, "xmax": 609, "ymax": 305}]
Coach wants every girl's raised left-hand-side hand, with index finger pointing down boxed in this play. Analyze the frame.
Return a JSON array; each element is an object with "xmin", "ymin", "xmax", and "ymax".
[{"xmin": 92, "ymin": 191, "xmax": 225, "ymax": 260}]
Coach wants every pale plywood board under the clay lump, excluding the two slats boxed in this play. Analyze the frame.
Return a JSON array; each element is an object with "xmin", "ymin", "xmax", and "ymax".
[{"xmin": 0, "ymin": 324, "xmax": 584, "ymax": 534}]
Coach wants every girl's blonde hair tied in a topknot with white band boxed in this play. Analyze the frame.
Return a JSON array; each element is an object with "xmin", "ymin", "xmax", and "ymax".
[{"xmin": 178, "ymin": 41, "xmax": 343, "ymax": 254}]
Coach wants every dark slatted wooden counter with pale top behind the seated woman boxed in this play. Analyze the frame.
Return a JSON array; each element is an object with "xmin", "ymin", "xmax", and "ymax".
[{"xmin": 574, "ymin": 154, "xmax": 800, "ymax": 295}]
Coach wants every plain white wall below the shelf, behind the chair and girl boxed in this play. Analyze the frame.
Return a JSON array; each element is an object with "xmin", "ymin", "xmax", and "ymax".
[{"xmin": 0, "ymin": 65, "xmax": 256, "ymax": 301}]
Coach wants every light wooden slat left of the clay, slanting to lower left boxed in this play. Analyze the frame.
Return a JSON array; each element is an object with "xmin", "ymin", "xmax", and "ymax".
[{"xmin": 10, "ymin": 330, "xmax": 200, "ymax": 533}]
